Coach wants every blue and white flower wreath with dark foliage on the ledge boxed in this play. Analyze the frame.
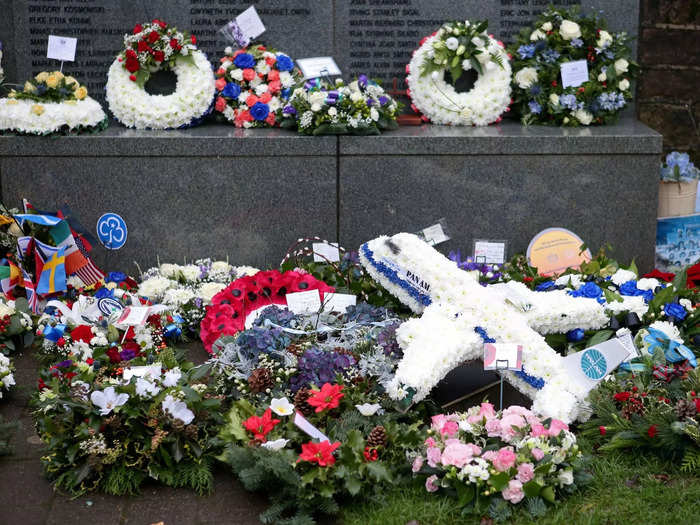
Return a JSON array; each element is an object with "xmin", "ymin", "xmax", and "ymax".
[{"xmin": 512, "ymin": 9, "xmax": 639, "ymax": 126}]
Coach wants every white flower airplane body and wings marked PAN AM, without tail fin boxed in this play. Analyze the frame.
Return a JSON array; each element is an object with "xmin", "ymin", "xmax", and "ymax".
[{"xmin": 360, "ymin": 233, "xmax": 607, "ymax": 422}]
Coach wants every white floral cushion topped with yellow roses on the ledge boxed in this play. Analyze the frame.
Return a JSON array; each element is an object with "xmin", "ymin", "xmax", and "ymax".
[{"xmin": 0, "ymin": 71, "xmax": 107, "ymax": 135}]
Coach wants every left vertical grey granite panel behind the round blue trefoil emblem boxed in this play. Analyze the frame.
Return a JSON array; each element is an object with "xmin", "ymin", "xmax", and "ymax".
[{"xmin": 0, "ymin": 152, "xmax": 336, "ymax": 274}]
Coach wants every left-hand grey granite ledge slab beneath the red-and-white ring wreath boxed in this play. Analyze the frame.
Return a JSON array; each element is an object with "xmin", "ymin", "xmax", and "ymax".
[{"xmin": 0, "ymin": 123, "xmax": 336, "ymax": 157}]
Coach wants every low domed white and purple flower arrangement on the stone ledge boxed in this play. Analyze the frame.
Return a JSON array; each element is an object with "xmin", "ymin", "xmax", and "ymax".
[{"xmin": 281, "ymin": 75, "xmax": 400, "ymax": 135}]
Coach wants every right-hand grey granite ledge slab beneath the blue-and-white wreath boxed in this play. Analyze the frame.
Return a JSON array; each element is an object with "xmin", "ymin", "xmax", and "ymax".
[{"xmin": 339, "ymin": 118, "xmax": 662, "ymax": 156}]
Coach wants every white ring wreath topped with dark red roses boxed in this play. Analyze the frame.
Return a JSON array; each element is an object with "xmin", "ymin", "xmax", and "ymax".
[{"xmin": 106, "ymin": 19, "xmax": 215, "ymax": 129}]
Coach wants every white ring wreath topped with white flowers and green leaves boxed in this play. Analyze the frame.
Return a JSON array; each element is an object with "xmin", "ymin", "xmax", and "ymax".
[{"xmin": 406, "ymin": 21, "xmax": 510, "ymax": 126}]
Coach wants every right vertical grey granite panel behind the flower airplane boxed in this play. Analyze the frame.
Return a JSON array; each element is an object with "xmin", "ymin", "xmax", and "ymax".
[{"xmin": 339, "ymin": 148, "xmax": 659, "ymax": 270}]
